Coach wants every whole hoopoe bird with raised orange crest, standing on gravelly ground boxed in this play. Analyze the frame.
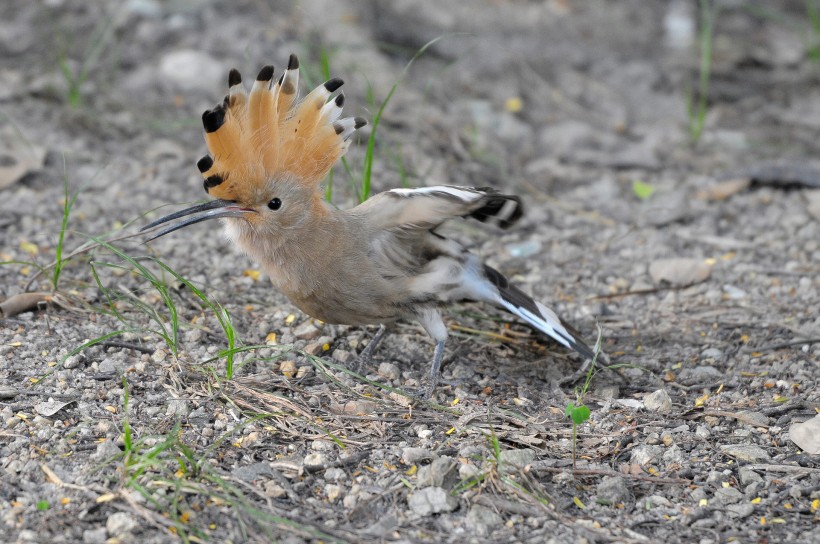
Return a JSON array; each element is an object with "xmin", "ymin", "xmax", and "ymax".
[{"xmin": 142, "ymin": 55, "xmax": 593, "ymax": 397}]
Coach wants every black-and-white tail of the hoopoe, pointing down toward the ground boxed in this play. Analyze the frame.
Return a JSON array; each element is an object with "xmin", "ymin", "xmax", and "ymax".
[{"xmin": 484, "ymin": 265, "xmax": 595, "ymax": 359}]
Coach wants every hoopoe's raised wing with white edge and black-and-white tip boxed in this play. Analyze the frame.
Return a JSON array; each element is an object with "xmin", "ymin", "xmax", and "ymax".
[{"xmin": 351, "ymin": 185, "xmax": 523, "ymax": 230}]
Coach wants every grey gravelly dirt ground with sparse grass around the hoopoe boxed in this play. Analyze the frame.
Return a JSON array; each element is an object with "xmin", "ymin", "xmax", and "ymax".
[{"xmin": 0, "ymin": 0, "xmax": 820, "ymax": 544}]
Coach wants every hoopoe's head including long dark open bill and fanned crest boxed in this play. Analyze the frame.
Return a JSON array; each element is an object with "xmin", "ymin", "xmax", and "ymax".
[{"xmin": 142, "ymin": 55, "xmax": 366, "ymax": 241}]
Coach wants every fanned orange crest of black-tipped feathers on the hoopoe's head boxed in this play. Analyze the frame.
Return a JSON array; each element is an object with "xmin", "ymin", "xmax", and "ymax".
[{"xmin": 197, "ymin": 55, "xmax": 366, "ymax": 201}]
